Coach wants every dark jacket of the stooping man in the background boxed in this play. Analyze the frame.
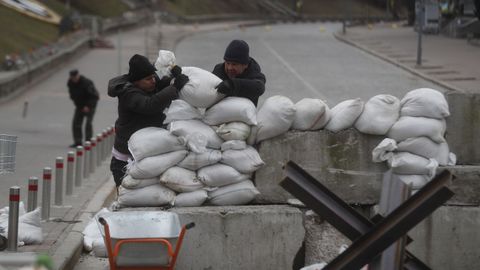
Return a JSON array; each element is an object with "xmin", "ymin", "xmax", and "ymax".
[{"xmin": 67, "ymin": 75, "xmax": 99, "ymax": 108}]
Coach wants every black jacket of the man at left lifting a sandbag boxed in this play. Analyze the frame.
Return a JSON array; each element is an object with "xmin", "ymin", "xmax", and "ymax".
[{"xmin": 108, "ymin": 75, "xmax": 178, "ymax": 154}]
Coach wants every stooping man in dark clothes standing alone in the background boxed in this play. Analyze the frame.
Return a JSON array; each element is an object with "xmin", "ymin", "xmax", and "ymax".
[{"xmin": 67, "ymin": 69, "xmax": 99, "ymax": 147}]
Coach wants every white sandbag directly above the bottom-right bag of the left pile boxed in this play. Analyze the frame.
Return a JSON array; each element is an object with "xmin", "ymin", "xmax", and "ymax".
[{"xmin": 197, "ymin": 164, "xmax": 250, "ymax": 187}]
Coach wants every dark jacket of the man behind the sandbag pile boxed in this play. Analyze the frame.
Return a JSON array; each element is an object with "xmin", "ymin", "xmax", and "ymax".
[{"xmin": 212, "ymin": 57, "xmax": 266, "ymax": 106}]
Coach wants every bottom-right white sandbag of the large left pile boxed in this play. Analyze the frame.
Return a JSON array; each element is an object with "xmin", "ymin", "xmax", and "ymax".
[{"xmin": 208, "ymin": 180, "xmax": 260, "ymax": 205}]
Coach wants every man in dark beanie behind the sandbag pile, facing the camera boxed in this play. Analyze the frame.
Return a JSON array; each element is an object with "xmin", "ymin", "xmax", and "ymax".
[{"xmin": 212, "ymin": 40, "xmax": 266, "ymax": 106}]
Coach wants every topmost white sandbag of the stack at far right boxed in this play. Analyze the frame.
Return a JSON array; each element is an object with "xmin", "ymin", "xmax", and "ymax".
[{"xmin": 400, "ymin": 88, "xmax": 450, "ymax": 119}]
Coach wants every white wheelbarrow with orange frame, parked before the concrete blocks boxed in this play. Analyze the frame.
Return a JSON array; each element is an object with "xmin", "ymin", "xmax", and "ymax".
[{"xmin": 97, "ymin": 211, "xmax": 195, "ymax": 270}]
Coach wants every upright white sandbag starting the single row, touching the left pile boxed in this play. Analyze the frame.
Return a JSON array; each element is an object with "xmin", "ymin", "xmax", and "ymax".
[{"xmin": 255, "ymin": 96, "xmax": 295, "ymax": 143}]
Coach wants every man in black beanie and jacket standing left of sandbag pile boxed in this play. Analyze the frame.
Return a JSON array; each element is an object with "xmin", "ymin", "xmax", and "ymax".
[{"xmin": 108, "ymin": 54, "xmax": 188, "ymax": 187}]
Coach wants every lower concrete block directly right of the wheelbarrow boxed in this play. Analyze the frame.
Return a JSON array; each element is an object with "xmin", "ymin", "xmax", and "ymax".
[{"xmin": 172, "ymin": 205, "xmax": 305, "ymax": 270}]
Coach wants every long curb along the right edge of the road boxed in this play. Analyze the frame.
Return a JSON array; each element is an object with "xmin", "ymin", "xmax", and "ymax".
[{"xmin": 333, "ymin": 32, "xmax": 467, "ymax": 93}]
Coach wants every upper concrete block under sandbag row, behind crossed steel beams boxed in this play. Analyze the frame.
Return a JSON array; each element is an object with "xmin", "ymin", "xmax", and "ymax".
[{"xmin": 255, "ymin": 128, "xmax": 387, "ymax": 204}]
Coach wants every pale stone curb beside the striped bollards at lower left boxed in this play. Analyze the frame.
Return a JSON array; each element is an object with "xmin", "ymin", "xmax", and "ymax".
[{"xmin": 52, "ymin": 176, "xmax": 115, "ymax": 270}]
